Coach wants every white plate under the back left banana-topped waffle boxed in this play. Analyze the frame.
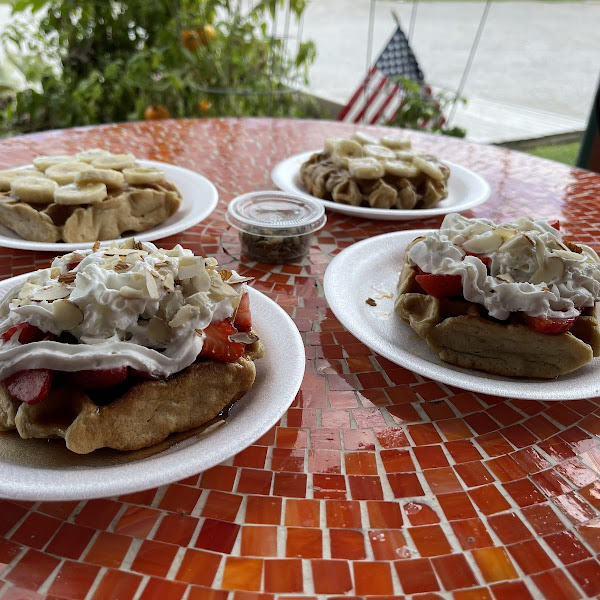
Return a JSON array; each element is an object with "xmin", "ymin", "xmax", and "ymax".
[{"xmin": 0, "ymin": 159, "xmax": 219, "ymax": 253}]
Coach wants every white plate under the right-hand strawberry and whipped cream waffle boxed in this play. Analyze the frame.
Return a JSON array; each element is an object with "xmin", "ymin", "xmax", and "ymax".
[{"xmin": 324, "ymin": 230, "xmax": 600, "ymax": 400}]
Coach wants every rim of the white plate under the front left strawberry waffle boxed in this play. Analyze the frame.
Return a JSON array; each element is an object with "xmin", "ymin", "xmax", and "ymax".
[{"xmin": 0, "ymin": 284, "xmax": 306, "ymax": 502}]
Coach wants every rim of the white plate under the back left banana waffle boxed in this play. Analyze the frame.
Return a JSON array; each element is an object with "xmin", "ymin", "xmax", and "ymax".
[{"xmin": 0, "ymin": 158, "xmax": 219, "ymax": 252}]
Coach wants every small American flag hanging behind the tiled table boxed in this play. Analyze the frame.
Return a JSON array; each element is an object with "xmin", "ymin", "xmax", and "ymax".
[{"xmin": 337, "ymin": 26, "xmax": 425, "ymax": 124}]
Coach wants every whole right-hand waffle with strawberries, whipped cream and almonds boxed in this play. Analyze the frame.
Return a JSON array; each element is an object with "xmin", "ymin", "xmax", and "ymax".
[{"xmin": 395, "ymin": 214, "xmax": 600, "ymax": 379}]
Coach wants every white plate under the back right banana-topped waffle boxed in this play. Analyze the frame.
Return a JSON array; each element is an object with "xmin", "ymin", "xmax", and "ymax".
[{"xmin": 271, "ymin": 150, "xmax": 490, "ymax": 221}]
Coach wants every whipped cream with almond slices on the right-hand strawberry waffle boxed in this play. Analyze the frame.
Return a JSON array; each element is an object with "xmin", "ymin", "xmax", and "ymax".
[{"xmin": 408, "ymin": 214, "xmax": 600, "ymax": 319}]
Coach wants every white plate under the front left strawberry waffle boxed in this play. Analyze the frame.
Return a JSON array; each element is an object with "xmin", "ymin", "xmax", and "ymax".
[{"xmin": 0, "ymin": 276, "xmax": 305, "ymax": 501}]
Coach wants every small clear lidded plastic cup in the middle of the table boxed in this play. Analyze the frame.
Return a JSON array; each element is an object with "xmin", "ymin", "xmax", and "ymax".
[{"xmin": 226, "ymin": 191, "xmax": 327, "ymax": 264}]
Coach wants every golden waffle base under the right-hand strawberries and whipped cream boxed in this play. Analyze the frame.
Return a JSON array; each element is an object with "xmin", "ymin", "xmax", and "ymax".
[{"xmin": 394, "ymin": 240, "xmax": 600, "ymax": 379}]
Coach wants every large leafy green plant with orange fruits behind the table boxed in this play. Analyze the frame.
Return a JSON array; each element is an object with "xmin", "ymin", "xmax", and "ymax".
[{"xmin": 0, "ymin": 0, "xmax": 315, "ymax": 132}]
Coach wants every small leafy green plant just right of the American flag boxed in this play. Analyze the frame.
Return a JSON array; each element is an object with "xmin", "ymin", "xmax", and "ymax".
[{"xmin": 388, "ymin": 77, "xmax": 467, "ymax": 138}]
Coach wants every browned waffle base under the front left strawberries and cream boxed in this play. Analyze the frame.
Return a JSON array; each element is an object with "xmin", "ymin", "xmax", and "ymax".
[{"xmin": 0, "ymin": 341, "xmax": 263, "ymax": 454}]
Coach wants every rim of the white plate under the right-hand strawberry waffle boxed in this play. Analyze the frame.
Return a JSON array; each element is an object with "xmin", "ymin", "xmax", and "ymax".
[{"xmin": 323, "ymin": 229, "xmax": 600, "ymax": 401}]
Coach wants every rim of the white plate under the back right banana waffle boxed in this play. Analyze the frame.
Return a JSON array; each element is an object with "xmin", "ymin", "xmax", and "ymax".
[{"xmin": 271, "ymin": 150, "xmax": 492, "ymax": 221}]
